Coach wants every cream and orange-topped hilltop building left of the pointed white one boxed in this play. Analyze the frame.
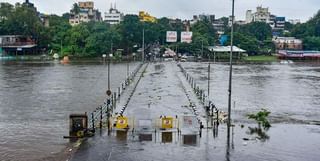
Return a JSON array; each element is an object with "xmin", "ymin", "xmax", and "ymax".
[{"xmin": 69, "ymin": 1, "xmax": 102, "ymax": 26}]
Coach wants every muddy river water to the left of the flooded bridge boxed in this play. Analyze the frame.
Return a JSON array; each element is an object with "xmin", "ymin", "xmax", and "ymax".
[{"xmin": 0, "ymin": 62, "xmax": 137, "ymax": 161}]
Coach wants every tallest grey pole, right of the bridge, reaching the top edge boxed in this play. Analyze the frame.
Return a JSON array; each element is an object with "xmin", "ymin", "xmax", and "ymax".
[{"xmin": 228, "ymin": 0, "xmax": 234, "ymax": 128}]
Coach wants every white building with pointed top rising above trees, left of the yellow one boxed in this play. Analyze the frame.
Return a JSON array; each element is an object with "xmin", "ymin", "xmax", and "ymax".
[{"xmin": 104, "ymin": 4, "xmax": 124, "ymax": 25}]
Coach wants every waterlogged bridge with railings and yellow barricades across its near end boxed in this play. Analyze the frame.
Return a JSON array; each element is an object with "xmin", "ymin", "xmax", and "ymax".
[{"xmin": 66, "ymin": 62, "xmax": 226, "ymax": 160}]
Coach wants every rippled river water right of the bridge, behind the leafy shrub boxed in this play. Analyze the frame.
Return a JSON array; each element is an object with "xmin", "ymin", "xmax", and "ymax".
[{"xmin": 182, "ymin": 62, "xmax": 320, "ymax": 124}]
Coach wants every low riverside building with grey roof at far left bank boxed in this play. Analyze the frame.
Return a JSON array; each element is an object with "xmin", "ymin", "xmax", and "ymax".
[{"xmin": 0, "ymin": 35, "xmax": 37, "ymax": 55}]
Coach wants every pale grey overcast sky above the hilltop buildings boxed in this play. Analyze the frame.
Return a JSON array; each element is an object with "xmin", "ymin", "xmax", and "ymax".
[{"xmin": 1, "ymin": 0, "xmax": 320, "ymax": 21}]
